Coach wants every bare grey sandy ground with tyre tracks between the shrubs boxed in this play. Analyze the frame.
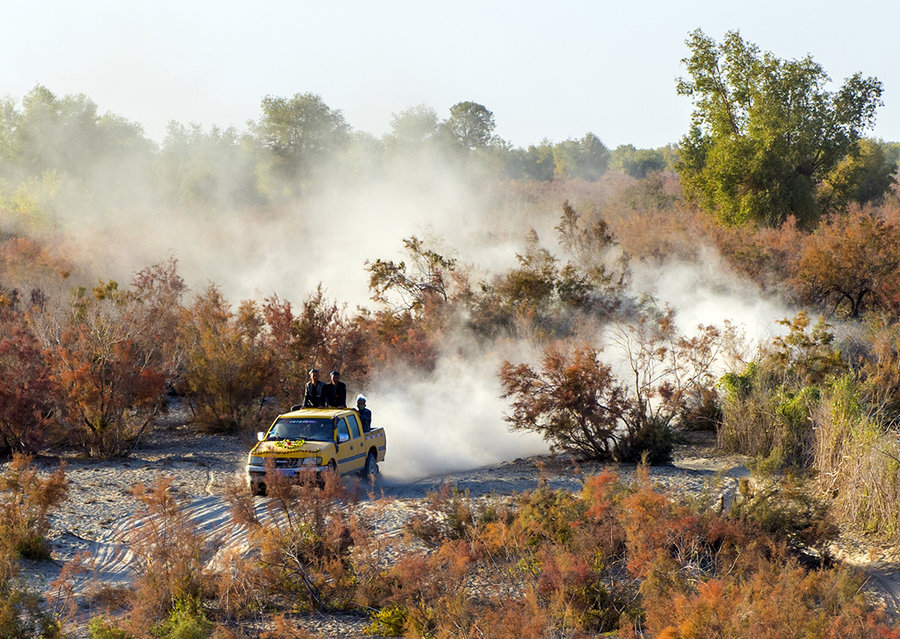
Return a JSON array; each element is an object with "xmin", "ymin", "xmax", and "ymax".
[{"xmin": 8, "ymin": 412, "xmax": 900, "ymax": 637}]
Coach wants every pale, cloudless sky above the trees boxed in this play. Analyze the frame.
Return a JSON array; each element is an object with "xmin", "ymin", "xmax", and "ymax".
[{"xmin": 0, "ymin": 0, "xmax": 900, "ymax": 148}]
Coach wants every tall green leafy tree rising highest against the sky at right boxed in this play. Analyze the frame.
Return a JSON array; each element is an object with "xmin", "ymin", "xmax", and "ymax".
[{"xmin": 678, "ymin": 29, "xmax": 882, "ymax": 226}]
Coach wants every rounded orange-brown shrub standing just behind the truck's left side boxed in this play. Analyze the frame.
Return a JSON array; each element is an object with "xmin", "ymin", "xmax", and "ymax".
[{"xmin": 176, "ymin": 285, "xmax": 276, "ymax": 432}]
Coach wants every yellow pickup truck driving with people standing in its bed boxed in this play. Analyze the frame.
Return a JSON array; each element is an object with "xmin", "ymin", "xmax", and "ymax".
[{"xmin": 247, "ymin": 408, "xmax": 387, "ymax": 495}]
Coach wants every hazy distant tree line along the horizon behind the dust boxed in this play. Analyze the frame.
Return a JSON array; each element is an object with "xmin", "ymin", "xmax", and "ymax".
[{"xmin": 0, "ymin": 85, "xmax": 676, "ymax": 214}]
